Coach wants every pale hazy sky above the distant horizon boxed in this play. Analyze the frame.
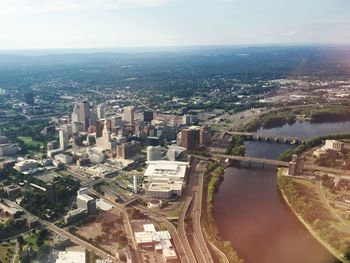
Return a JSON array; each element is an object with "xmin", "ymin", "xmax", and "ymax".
[{"xmin": 0, "ymin": 0, "xmax": 350, "ymax": 49}]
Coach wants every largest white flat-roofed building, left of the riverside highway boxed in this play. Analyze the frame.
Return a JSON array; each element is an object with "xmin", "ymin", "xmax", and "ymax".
[{"xmin": 143, "ymin": 161, "xmax": 189, "ymax": 199}]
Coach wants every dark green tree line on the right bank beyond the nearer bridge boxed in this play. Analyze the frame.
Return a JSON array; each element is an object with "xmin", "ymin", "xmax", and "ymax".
[{"xmin": 278, "ymin": 133, "xmax": 350, "ymax": 162}]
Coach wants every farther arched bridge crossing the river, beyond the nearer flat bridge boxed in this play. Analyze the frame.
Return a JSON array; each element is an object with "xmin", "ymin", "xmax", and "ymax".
[{"xmin": 222, "ymin": 131, "xmax": 305, "ymax": 144}]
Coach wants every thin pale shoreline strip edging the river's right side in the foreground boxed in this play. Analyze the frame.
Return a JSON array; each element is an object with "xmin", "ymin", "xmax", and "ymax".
[{"xmin": 277, "ymin": 174, "xmax": 349, "ymax": 262}]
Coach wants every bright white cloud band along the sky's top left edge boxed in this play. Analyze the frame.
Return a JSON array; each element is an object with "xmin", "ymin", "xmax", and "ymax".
[{"xmin": 0, "ymin": 0, "xmax": 168, "ymax": 15}]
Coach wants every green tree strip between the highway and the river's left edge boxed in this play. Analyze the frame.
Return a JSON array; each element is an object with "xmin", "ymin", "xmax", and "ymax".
[{"xmin": 204, "ymin": 163, "xmax": 243, "ymax": 263}]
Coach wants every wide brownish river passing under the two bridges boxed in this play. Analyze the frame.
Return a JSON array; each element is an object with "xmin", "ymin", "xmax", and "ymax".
[{"xmin": 214, "ymin": 122, "xmax": 350, "ymax": 263}]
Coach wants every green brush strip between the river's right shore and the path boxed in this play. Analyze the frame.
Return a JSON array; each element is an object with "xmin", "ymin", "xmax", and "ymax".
[{"xmin": 277, "ymin": 175, "xmax": 350, "ymax": 258}]
